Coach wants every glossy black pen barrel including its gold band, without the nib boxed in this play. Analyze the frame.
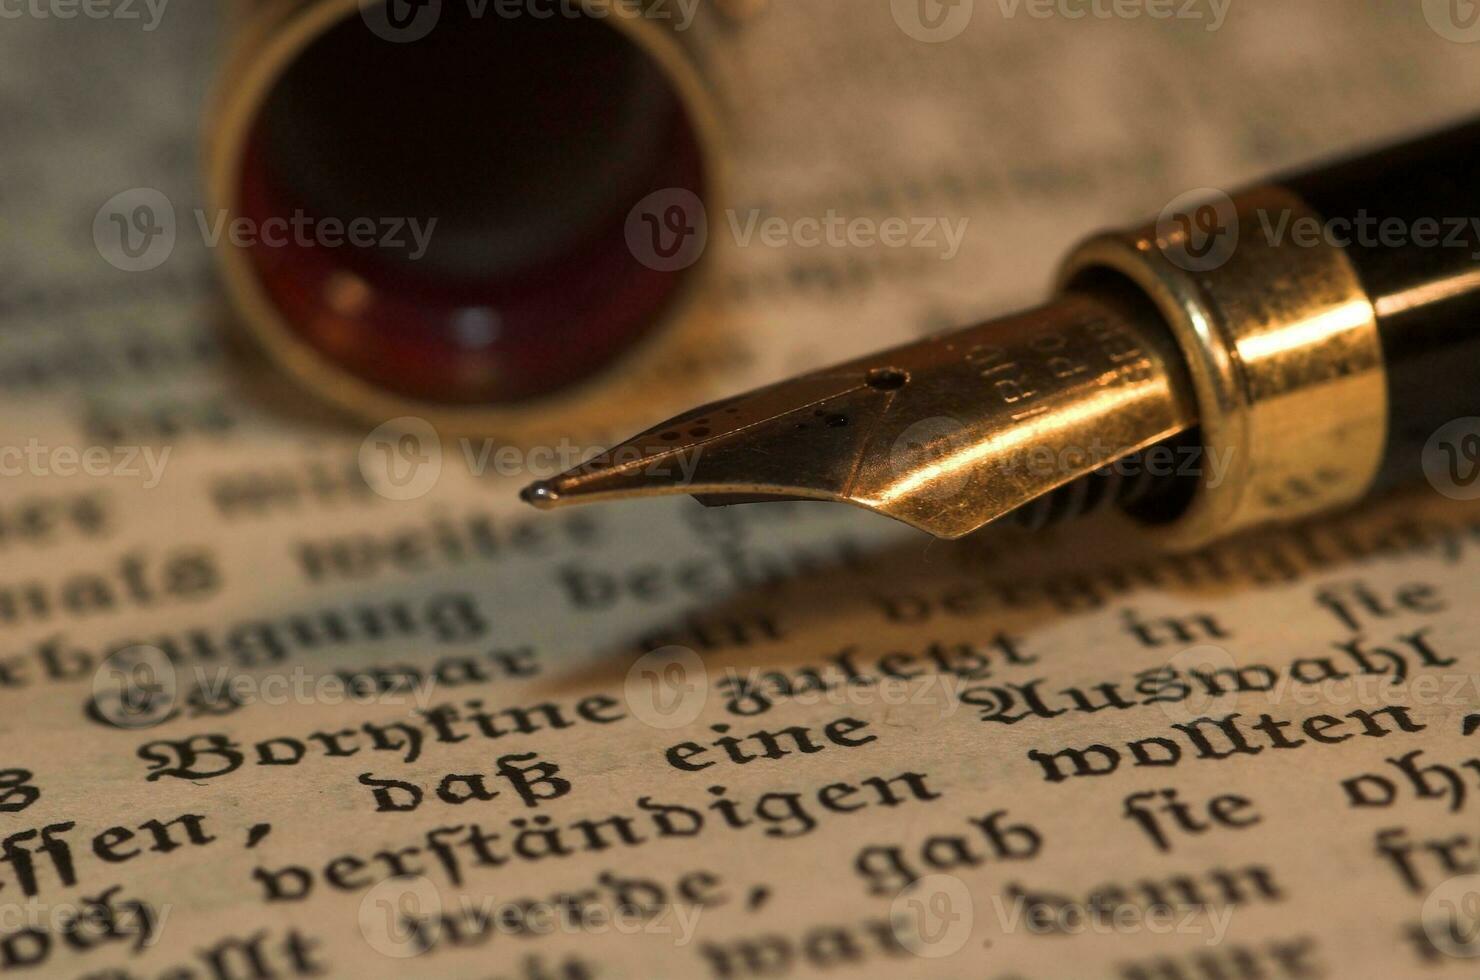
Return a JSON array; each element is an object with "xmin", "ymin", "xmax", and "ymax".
[{"xmin": 1054, "ymin": 120, "xmax": 1480, "ymax": 548}]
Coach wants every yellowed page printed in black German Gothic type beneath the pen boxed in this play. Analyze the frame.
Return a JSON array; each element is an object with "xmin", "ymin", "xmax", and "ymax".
[{"xmin": 0, "ymin": 0, "xmax": 1480, "ymax": 980}]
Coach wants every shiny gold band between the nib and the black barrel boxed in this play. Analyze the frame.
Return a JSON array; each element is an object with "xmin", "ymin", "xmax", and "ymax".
[{"xmin": 1060, "ymin": 187, "xmax": 1388, "ymax": 548}]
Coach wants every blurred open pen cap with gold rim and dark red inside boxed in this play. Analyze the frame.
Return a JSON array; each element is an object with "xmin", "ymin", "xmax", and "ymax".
[{"xmin": 207, "ymin": 0, "xmax": 721, "ymax": 429}]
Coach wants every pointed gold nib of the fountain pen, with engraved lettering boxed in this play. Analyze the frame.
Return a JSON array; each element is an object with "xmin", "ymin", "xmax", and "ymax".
[{"xmin": 522, "ymin": 293, "xmax": 1197, "ymax": 537}]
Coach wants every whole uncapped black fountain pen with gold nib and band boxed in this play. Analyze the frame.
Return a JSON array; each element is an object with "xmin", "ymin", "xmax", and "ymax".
[{"xmin": 522, "ymin": 120, "xmax": 1480, "ymax": 548}]
